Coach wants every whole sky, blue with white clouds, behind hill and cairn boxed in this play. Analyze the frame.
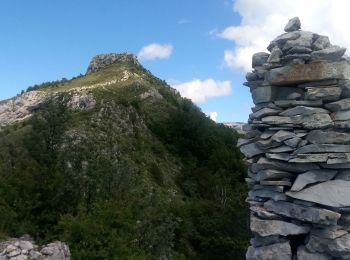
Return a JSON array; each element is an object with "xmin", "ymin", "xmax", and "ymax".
[{"xmin": 0, "ymin": 0, "xmax": 350, "ymax": 122}]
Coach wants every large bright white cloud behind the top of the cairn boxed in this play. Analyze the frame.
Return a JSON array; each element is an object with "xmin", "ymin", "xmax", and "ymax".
[{"xmin": 218, "ymin": 0, "xmax": 350, "ymax": 71}]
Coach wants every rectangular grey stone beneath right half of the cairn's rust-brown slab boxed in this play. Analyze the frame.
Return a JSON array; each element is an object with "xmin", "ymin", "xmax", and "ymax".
[{"xmin": 305, "ymin": 86, "xmax": 341, "ymax": 101}]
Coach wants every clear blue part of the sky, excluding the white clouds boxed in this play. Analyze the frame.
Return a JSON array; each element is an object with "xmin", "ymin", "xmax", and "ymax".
[{"xmin": 0, "ymin": 0, "xmax": 249, "ymax": 121}]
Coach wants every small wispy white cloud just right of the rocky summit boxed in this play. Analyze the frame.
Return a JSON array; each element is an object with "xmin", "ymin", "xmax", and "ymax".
[{"xmin": 137, "ymin": 43, "xmax": 173, "ymax": 60}]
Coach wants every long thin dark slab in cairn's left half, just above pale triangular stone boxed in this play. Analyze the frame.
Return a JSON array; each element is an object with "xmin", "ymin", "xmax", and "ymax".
[{"xmin": 252, "ymin": 157, "xmax": 320, "ymax": 173}]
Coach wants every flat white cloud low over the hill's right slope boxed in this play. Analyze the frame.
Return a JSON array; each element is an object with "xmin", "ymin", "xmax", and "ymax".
[{"xmin": 172, "ymin": 79, "xmax": 232, "ymax": 103}]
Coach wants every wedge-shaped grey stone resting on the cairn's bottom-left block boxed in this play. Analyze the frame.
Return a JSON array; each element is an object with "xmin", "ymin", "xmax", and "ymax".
[{"xmin": 250, "ymin": 215, "xmax": 310, "ymax": 237}]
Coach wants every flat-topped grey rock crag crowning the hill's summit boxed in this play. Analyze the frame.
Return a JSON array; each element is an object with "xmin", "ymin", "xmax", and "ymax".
[{"xmin": 86, "ymin": 53, "xmax": 139, "ymax": 74}]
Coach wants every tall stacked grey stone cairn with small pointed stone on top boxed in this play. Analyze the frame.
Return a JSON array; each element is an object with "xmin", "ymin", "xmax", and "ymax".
[{"xmin": 238, "ymin": 17, "xmax": 350, "ymax": 260}]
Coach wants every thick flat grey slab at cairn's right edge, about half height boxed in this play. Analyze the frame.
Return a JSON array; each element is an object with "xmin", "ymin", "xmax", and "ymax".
[{"xmin": 306, "ymin": 130, "xmax": 350, "ymax": 144}]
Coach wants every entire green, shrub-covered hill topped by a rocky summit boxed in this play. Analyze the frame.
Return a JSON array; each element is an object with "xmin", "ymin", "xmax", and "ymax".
[{"xmin": 0, "ymin": 54, "xmax": 248, "ymax": 259}]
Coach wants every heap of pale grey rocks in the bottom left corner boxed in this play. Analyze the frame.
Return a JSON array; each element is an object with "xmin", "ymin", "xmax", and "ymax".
[{"xmin": 0, "ymin": 236, "xmax": 71, "ymax": 260}]
